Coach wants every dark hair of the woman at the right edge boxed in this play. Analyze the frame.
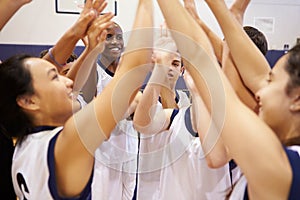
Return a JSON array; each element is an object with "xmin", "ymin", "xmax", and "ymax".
[{"xmin": 285, "ymin": 44, "xmax": 300, "ymax": 95}]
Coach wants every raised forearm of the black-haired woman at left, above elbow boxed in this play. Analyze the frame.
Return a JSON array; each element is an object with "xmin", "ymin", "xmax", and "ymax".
[{"xmin": 95, "ymin": 0, "xmax": 153, "ymax": 138}]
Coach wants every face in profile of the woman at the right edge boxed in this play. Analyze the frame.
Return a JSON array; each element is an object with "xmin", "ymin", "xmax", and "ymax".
[{"xmin": 256, "ymin": 55, "xmax": 292, "ymax": 139}]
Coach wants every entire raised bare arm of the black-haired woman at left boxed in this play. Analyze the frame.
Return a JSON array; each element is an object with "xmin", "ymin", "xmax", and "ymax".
[{"xmin": 55, "ymin": 0, "xmax": 152, "ymax": 197}]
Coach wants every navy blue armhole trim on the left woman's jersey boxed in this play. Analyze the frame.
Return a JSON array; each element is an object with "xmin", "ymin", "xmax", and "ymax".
[{"xmin": 47, "ymin": 131, "xmax": 93, "ymax": 200}]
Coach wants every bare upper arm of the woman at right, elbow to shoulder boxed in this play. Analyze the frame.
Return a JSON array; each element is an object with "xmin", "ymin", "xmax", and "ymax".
[{"xmin": 222, "ymin": 101, "xmax": 292, "ymax": 199}]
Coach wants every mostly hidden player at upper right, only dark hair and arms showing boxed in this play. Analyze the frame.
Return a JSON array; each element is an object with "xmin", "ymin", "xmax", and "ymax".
[{"xmin": 184, "ymin": 0, "xmax": 268, "ymax": 113}]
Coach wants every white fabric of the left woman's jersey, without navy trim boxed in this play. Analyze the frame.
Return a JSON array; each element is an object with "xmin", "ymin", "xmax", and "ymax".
[{"xmin": 12, "ymin": 127, "xmax": 62, "ymax": 200}]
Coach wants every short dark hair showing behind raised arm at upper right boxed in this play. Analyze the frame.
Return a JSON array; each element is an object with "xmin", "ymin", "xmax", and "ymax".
[{"xmin": 243, "ymin": 26, "xmax": 268, "ymax": 55}]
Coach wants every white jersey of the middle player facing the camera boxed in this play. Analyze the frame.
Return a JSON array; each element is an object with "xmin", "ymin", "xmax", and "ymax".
[{"xmin": 138, "ymin": 108, "xmax": 231, "ymax": 200}]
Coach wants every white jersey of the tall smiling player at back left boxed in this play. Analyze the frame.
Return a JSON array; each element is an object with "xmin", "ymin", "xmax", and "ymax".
[{"xmin": 92, "ymin": 64, "xmax": 138, "ymax": 200}]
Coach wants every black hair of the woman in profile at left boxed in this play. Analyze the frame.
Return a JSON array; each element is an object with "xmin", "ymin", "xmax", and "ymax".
[{"xmin": 0, "ymin": 55, "xmax": 34, "ymax": 141}]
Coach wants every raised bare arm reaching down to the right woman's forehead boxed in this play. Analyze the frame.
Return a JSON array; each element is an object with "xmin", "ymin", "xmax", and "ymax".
[{"xmin": 206, "ymin": 0, "xmax": 270, "ymax": 93}]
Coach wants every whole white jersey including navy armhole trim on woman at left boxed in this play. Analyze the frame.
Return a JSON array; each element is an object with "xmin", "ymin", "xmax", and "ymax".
[{"xmin": 12, "ymin": 127, "xmax": 92, "ymax": 199}]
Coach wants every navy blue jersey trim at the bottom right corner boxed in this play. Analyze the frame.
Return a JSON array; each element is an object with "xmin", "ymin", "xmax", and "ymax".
[{"xmin": 285, "ymin": 148, "xmax": 300, "ymax": 200}]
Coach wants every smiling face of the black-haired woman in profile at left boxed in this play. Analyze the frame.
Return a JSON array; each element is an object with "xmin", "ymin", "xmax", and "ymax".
[{"xmin": 25, "ymin": 58, "xmax": 74, "ymax": 125}]
